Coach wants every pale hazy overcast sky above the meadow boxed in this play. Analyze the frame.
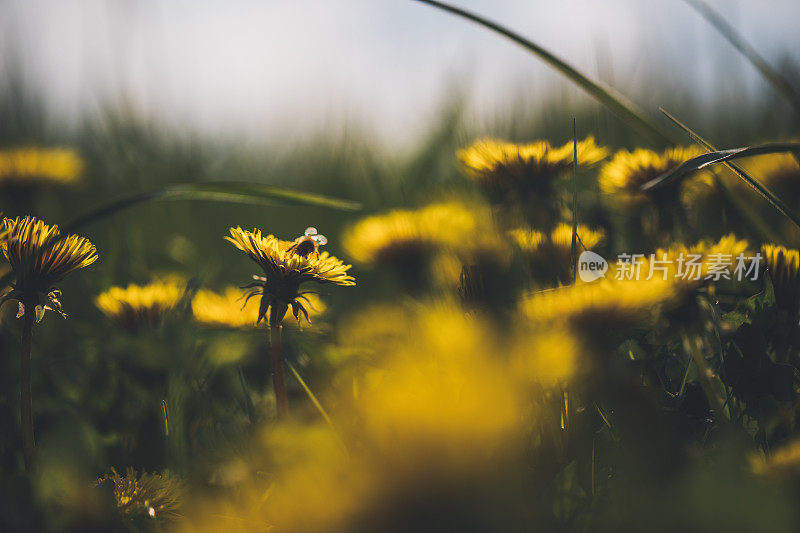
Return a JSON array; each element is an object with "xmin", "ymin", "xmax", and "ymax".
[{"xmin": 0, "ymin": 0, "xmax": 800, "ymax": 139}]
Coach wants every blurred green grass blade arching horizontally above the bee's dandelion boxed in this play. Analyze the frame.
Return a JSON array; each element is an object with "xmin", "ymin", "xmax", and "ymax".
[{"xmin": 64, "ymin": 181, "xmax": 361, "ymax": 233}]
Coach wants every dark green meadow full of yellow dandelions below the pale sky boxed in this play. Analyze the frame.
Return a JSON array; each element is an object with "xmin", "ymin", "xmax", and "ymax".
[{"xmin": 0, "ymin": 2, "xmax": 800, "ymax": 532}]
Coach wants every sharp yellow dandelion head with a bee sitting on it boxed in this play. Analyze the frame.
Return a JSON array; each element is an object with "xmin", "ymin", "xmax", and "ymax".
[{"xmin": 225, "ymin": 227, "xmax": 356, "ymax": 325}]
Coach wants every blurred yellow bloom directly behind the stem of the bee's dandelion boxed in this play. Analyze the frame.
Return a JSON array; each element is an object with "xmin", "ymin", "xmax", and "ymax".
[{"xmin": 192, "ymin": 287, "xmax": 325, "ymax": 328}]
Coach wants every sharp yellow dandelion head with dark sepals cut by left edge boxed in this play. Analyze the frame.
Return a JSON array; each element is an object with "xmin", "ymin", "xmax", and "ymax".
[{"xmin": 0, "ymin": 217, "xmax": 97, "ymax": 318}]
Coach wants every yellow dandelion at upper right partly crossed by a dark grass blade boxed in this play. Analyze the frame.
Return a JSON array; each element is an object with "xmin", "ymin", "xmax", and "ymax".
[{"xmin": 599, "ymin": 146, "xmax": 714, "ymax": 206}]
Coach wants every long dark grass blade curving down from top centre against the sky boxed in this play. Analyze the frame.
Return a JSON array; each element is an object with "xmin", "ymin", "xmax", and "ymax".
[{"xmin": 415, "ymin": 0, "xmax": 676, "ymax": 144}]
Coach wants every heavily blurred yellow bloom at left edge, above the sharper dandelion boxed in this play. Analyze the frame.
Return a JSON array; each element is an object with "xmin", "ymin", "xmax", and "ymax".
[{"xmin": 0, "ymin": 147, "xmax": 84, "ymax": 185}]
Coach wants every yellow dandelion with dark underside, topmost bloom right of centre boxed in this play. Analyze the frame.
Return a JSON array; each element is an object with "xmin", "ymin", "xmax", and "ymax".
[{"xmin": 457, "ymin": 137, "xmax": 608, "ymax": 193}]
